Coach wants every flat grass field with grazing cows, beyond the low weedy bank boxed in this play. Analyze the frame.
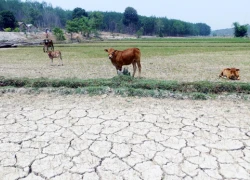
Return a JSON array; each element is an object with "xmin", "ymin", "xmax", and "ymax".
[{"xmin": 0, "ymin": 38, "xmax": 250, "ymax": 82}]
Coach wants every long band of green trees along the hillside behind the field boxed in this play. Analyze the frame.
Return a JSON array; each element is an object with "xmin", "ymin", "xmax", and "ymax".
[{"xmin": 0, "ymin": 0, "xmax": 211, "ymax": 37}]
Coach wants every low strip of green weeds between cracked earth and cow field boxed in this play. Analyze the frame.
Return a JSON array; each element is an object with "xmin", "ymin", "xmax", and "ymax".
[{"xmin": 0, "ymin": 76, "xmax": 250, "ymax": 99}]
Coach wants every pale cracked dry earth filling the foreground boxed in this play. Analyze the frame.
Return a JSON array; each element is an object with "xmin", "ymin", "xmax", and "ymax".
[{"xmin": 0, "ymin": 93, "xmax": 250, "ymax": 180}]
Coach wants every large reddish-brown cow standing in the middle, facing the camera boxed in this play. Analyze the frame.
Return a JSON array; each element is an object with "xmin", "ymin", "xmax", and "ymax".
[{"xmin": 104, "ymin": 48, "xmax": 141, "ymax": 77}]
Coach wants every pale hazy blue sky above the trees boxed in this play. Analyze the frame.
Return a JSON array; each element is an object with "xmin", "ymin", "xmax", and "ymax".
[{"xmin": 34, "ymin": 0, "xmax": 250, "ymax": 30}]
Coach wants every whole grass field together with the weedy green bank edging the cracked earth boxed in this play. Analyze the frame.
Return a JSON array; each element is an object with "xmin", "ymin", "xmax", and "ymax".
[{"xmin": 0, "ymin": 38, "xmax": 250, "ymax": 99}]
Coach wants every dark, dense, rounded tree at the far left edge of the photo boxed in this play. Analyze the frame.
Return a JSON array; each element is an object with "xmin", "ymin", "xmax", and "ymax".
[{"xmin": 0, "ymin": 11, "xmax": 17, "ymax": 29}]
